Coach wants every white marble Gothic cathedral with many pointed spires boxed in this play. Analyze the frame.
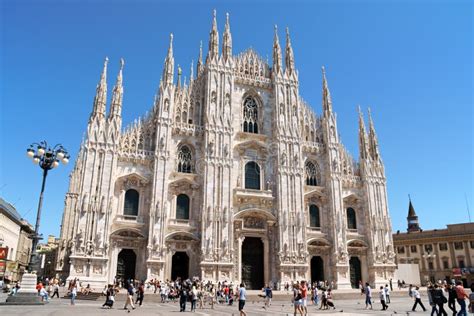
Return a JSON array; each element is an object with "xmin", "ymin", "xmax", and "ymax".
[{"xmin": 56, "ymin": 13, "xmax": 395, "ymax": 289}]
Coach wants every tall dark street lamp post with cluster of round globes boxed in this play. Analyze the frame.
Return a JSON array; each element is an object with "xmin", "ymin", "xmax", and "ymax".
[{"xmin": 26, "ymin": 141, "xmax": 69, "ymax": 273}]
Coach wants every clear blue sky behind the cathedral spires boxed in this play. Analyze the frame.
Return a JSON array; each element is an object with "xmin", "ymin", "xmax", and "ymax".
[{"xmin": 0, "ymin": 0, "xmax": 474, "ymax": 235}]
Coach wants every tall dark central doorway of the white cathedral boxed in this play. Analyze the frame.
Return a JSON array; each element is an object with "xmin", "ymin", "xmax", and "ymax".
[{"xmin": 242, "ymin": 237, "xmax": 264, "ymax": 290}]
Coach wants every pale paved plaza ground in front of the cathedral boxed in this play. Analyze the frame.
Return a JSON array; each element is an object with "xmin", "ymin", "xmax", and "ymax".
[{"xmin": 0, "ymin": 294, "xmax": 436, "ymax": 316}]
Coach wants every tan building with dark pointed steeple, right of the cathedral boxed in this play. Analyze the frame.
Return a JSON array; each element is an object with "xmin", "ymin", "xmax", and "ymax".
[{"xmin": 393, "ymin": 201, "xmax": 474, "ymax": 287}]
